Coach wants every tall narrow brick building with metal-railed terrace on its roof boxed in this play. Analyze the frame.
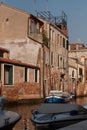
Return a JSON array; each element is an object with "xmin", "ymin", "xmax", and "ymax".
[{"xmin": 38, "ymin": 11, "xmax": 68, "ymax": 91}]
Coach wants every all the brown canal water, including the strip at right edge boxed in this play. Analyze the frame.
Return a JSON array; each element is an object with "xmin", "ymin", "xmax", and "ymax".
[{"xmin": 6, "ymin": 97, "xmax": 87, "ymax": 130}]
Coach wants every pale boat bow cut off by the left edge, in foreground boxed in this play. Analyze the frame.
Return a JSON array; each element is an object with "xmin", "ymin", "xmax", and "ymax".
[{"xmin": 0, "ymin": 96, "xmax": 21, "ymax": 130}]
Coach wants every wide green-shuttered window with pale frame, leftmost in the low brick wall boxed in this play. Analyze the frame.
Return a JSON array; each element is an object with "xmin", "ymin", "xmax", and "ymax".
[{"xmin": 4, "ymin": 65, "xmax": 13, "ymax": 85}]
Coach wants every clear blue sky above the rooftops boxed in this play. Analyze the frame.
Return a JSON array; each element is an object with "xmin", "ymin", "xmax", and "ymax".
[{"xmin": 0, "ymin": 0, "xmax": 87, "ymax": 44}]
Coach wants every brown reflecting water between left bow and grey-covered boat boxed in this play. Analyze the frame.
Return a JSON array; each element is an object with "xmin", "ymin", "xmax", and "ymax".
[{"xmin": 6, "ymin": 104, "xmax": 39, "ymax": 130}]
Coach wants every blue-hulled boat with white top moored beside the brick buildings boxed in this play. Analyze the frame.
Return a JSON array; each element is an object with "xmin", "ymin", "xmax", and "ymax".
[{"xmin": 44, "ymin": 90, "xmax": 71, "ymax": 103}]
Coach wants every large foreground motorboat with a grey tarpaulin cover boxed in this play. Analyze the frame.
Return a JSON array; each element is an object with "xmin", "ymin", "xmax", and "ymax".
[{"xmin": 30, "ymin": 103, "xmax": 87, "ymax": 130}]
